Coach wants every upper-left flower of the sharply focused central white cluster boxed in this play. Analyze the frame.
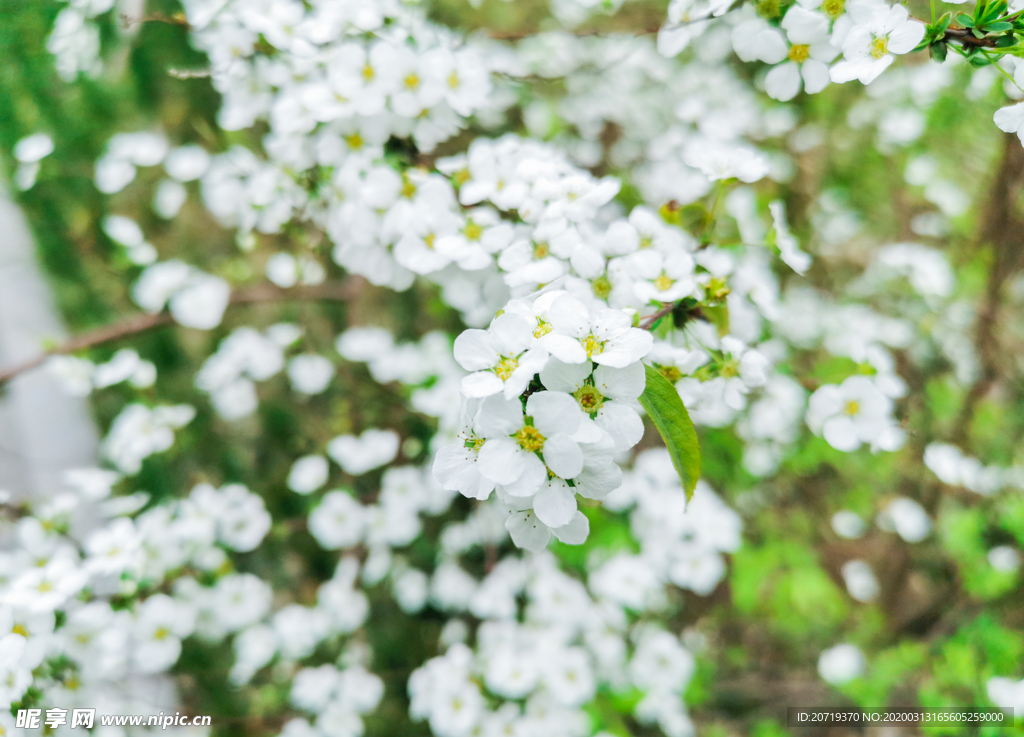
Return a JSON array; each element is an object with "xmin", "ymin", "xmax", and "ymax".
[{"xmin": 455, "ymin": 313, "xmax": 552, "ymax": 399}]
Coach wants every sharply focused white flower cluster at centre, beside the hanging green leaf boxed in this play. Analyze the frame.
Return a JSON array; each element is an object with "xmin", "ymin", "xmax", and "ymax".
[{"xmin": 434, "ymin": 290, "xmax": 653, "ymax": 551}]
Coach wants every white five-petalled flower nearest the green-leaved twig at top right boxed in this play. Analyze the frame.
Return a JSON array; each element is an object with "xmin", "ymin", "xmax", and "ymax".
[{"xmin": 829, "ymin": 5, "xmax": 925, "ymax": 84}]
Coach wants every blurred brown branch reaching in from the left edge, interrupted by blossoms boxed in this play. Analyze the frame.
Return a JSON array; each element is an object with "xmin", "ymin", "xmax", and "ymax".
[{"xmin": 0, "ymin": 277, "xmax": 362, "ymax": 387}]
